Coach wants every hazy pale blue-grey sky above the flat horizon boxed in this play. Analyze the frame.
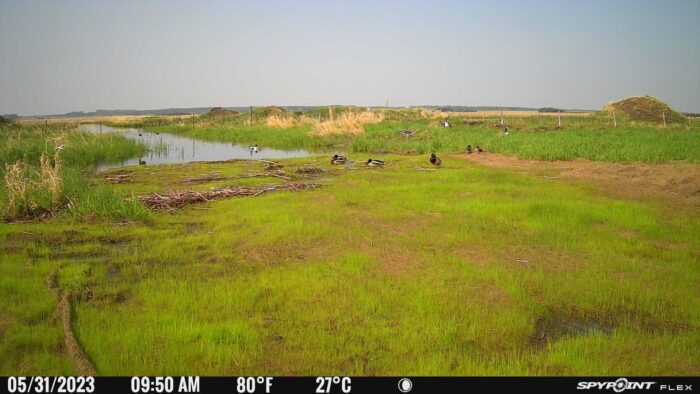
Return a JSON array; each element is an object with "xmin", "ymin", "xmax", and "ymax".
[{"xmin": 0, "ymin": 0, "xmax": 700, "ymax": 115}]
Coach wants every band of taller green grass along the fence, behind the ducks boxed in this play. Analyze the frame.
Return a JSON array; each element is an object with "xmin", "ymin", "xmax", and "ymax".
[{"xmin": 138, "ymin": 112, "xmax": 700, "ymax": 163}]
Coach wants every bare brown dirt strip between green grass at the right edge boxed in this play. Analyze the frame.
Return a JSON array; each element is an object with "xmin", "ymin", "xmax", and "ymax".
[{"xmin": 459, "ymin": 152, "xmax": 700, "ymax": 213}]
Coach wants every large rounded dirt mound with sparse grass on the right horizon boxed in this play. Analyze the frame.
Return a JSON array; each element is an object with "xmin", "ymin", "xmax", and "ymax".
[{"xmin": 603, "ymin": 96, "xmax": 686, "ymax": 124}]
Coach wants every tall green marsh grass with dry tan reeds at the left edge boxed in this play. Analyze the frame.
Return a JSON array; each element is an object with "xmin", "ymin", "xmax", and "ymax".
[{"xmin": 0, "ymin": 125, "xmax": 148, "ymax": 221}]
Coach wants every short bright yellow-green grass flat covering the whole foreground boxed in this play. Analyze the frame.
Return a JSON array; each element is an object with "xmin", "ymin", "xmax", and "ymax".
[{"xmin": 0, "ymin": 155, "xmax": 700, "ymax": 375}]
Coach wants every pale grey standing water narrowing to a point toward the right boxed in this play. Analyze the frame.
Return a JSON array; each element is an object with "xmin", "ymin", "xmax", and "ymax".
[{"xmin": 80, "ymin": 124, "xmax": 309, "ymax": 171}]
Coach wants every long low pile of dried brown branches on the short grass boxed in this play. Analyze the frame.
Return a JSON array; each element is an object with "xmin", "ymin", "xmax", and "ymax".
[{"xmin": 139, "ymin": 183, "xmax": 320, "ymax": 211}]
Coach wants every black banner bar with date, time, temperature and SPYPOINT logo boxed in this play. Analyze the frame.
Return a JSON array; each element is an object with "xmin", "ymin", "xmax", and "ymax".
[{"xmin": 0, "ymin": 376, "xmax": 700, "ymax": 394}]
